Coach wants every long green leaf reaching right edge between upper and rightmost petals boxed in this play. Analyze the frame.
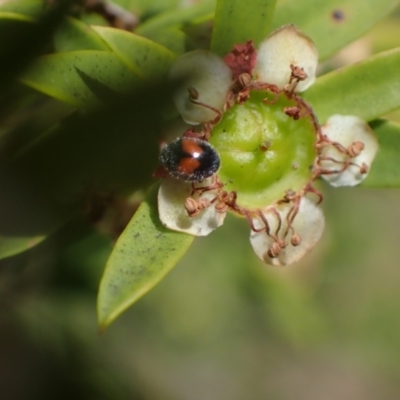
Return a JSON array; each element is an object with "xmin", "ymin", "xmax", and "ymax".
[{"xmin": 304, "ymin": 48, "xmax": 400, "ymax": 123}]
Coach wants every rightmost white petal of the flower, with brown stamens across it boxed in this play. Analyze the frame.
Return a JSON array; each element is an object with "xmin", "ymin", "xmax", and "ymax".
[{"xmin": 321, "ymin": 115, "xmax": 378, "ymax": 186}]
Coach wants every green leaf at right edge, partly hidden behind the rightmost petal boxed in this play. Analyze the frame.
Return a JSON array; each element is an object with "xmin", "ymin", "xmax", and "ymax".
[{"xmin": 362, "ymin": 119, "xmax": 400, "ymax": 188}]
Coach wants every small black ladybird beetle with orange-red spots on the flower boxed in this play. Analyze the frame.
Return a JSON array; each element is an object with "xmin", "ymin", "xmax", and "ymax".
[{"xmin": 160, "ymin": 137, "xmax": 220, "ymax": 182}]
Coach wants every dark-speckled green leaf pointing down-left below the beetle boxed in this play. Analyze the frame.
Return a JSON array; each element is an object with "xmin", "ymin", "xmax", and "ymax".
[{"xmin": 97, "ymin": 185, "xmax": 194, "ymax": 330}]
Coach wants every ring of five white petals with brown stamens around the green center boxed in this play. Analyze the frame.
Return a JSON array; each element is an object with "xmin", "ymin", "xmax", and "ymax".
[{"xmin": 158, "ymin": 25, "xmax": 378, "ymax": 265}]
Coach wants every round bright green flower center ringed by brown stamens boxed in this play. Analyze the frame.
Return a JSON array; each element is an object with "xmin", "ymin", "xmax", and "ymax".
[{"xmin": 210, "ymin": 91, "xmax": 316, "ymax": 209}]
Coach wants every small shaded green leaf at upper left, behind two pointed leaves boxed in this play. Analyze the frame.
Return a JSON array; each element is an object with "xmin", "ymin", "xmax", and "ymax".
[{"xmin": 54, "ymin": 18, "xmax": 110, "ymax": 52}]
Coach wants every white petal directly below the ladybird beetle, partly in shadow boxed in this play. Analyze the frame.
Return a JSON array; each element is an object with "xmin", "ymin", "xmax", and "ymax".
[{"xmin": 158, "ymin": 177, "xmax": 226, "ymax": 236}]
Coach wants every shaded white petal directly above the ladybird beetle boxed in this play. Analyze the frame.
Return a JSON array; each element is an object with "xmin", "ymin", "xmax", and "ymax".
[{"xmin": 169, "ymin": 50, "xmax": 232, "ymax": 125}]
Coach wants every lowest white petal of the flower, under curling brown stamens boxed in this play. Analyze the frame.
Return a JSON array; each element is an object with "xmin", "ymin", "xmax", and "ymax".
[{"xmin": 250, "ymin": 198, "xmax": 325, "ymax": 265}]
